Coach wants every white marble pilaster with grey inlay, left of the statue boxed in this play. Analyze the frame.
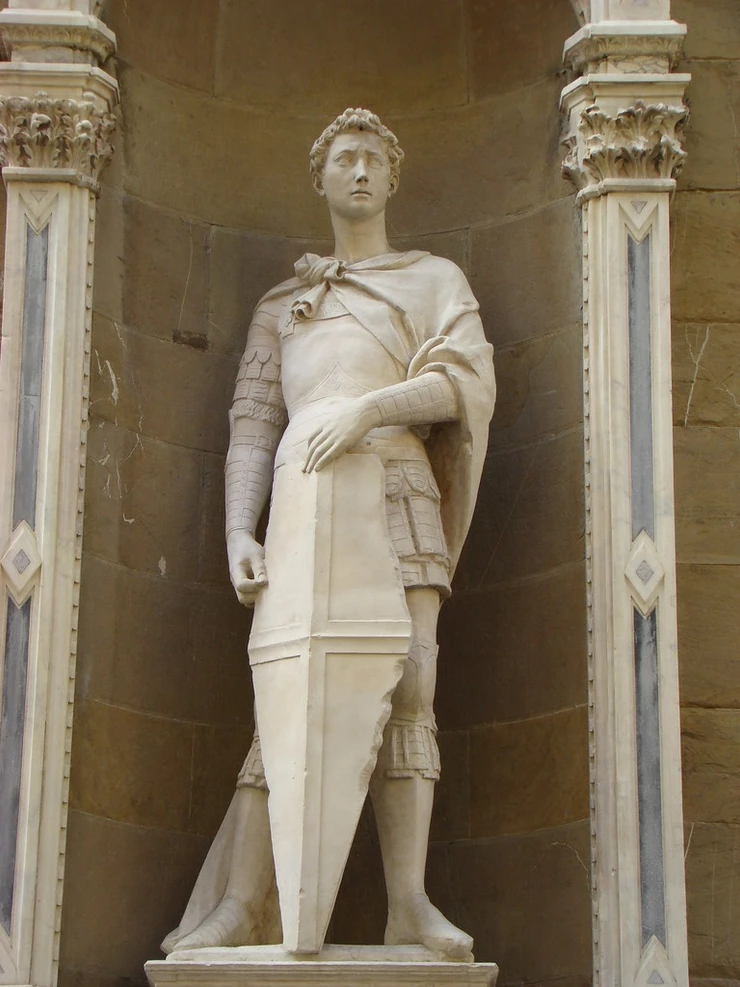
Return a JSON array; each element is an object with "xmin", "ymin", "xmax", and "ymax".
[{"xmin": 0, "ymin": 3, "xmax": 117, "ymax": 987}]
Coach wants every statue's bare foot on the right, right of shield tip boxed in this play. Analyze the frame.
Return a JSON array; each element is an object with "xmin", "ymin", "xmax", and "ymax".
[{"xmin": 385, "ymin": 892, "xmax": 473, "ymax": 963}]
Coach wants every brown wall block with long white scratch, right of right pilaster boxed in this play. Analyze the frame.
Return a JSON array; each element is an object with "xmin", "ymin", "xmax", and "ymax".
[{"xmin": 672, "ymin": 323, "xmax": 740, "ymax": 428}]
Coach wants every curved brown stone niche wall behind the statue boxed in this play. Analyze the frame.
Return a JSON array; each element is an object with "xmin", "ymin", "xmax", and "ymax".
[{"xmin": 61, "ymin": 0, "xmax": 591, "ymax": 987}]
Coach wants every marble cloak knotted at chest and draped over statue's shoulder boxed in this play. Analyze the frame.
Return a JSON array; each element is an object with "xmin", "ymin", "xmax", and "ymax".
[{"xmin": 257, "ymin": 250, "xmax": 496, "ymax": 567}]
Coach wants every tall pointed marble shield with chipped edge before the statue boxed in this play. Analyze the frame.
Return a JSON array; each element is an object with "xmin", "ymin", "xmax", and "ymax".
[{"xmin": 249, "ymin": 455, "xmax": 411, "ymax": 953}]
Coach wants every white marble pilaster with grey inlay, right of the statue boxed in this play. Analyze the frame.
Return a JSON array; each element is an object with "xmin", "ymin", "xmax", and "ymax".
[{"xmin": 562, "ymin": 7, "xmax": 689, "ymax": 985}]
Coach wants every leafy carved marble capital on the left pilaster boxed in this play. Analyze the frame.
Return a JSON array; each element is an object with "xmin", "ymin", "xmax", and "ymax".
[{"xmin": 0, "ymin": 92, "xmax": 116, "ymax": 189}]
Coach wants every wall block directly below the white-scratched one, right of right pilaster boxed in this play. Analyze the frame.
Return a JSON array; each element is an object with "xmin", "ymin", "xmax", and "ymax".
[{"xmin": 673, "ymin": 427, "xmax": 740, "ymax": 565}]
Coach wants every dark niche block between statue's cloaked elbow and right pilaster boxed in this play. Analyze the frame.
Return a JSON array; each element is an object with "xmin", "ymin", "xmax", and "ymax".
[{"xmin": 491, "ymin": 323, "xmax": 583, "ymax": 450}]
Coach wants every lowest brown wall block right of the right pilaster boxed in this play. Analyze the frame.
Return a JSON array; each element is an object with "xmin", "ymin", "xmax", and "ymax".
[{"xmin": 686, "ymin": 823, "xmax": 740, "ymax": 987}]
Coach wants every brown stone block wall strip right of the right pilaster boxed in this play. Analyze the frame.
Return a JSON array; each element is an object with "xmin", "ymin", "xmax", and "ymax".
[{"xmin": 672, "ymin": 0, "xmax": 740, "ymax": 984}]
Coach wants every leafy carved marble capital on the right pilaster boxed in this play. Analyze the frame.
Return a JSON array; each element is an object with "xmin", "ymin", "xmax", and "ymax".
[{"xmin": 563, "ymin": 101, "xmax": 689, "ymax": 189}]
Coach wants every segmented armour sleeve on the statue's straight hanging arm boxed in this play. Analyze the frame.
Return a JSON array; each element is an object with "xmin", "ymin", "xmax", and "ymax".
[{"xmin": 226, "ymin": 323, "xmax": 288, "ymax": 538}]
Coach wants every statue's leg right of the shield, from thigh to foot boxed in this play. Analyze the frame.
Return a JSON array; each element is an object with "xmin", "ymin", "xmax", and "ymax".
[{"xmin": 370, "ymin": 587, "xmax": 473, "ymax": 961}]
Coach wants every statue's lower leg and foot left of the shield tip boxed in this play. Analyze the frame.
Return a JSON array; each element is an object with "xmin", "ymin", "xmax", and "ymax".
[{"xmin": 175, "ymin": 734, "xmax": 279, "ymax": 950}]
